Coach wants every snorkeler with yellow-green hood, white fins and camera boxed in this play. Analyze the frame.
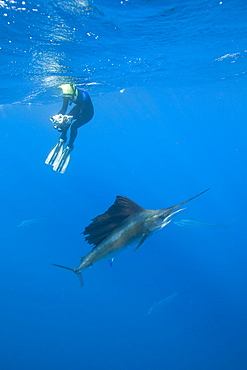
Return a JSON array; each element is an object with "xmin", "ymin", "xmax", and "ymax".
[{"xmin": 45, "ymin": 84, "xmax": 94, "ymax": 173}]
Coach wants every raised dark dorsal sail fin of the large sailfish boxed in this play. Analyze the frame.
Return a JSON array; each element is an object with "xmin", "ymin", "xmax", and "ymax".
[{"xmin": 83, "ymin": 196, "xmax": 144, "ymax": 246}]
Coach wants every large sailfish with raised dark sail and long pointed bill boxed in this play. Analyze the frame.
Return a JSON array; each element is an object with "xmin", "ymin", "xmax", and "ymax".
[{"xmin": 53, "ymin": 189, "xmax": 209, "ymax": 285}]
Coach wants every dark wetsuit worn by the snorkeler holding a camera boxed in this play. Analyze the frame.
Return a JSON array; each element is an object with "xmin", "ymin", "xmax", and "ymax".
[{"xmin": 58, "ymin": 87, "xmax": 94, "ymax": 149}]
